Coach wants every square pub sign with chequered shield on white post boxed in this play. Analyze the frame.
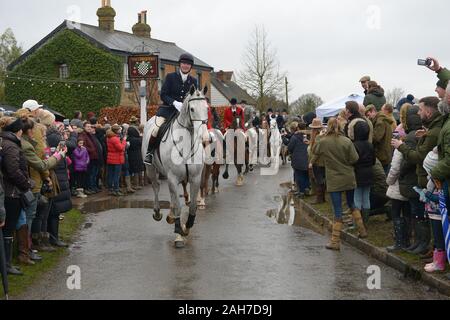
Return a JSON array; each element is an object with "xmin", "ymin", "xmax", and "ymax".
[{"xmin": 128, "ymin": 55, "xmax": 159, "ymax": 80}]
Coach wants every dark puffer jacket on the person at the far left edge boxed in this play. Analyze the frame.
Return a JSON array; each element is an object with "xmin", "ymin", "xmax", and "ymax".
[{"xmin": 0, "ymin": 132, "xmax": 31, "ymax": 199}]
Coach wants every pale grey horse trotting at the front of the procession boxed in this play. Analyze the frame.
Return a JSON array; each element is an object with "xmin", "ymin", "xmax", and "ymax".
[{"xmin": 142, "ymin": 86, "xmax": 208, "ymax": 248}]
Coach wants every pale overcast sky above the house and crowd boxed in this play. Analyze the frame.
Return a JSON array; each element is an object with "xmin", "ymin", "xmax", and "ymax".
[{"xmin": 0, "ymin": 0, "xmax": 450, "ymax": 101}]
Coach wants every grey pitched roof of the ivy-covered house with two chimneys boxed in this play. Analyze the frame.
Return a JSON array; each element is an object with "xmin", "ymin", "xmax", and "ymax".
[{"xmin": 8, "ymin": 20, "xmax": 213, "ymax": 70}]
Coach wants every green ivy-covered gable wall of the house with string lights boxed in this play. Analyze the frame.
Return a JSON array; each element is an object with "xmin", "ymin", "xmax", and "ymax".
[{"xmin": 5, "ymin": 30, "xmax": 123, "ymax": 118}]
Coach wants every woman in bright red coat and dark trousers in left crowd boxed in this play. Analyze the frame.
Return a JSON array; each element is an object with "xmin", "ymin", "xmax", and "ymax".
[{"xmin": 106, "ymin": 125, "xmax": 127, "ymax": 197}]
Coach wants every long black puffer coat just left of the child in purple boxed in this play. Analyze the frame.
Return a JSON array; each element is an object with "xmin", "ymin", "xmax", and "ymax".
[{"xmin": 47, "ymin": 128, "xmax": 72, "ymax": 215}]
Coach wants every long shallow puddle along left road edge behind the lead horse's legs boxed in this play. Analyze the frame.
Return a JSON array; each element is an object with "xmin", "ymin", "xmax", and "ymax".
[{"xmin": 81, "ymin": 198, "xmax": 170, "ymax": 214}]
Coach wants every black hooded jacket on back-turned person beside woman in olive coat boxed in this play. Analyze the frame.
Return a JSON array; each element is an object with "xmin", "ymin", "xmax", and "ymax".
[{"xmin": 353, "ymin": 121, "xmax": 376, "ymax": 187}]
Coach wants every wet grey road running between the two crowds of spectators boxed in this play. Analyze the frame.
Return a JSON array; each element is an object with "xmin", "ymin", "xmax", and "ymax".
[{"xmin": 21, "ymin": 167, "xmax": 444, "ymax": 300}]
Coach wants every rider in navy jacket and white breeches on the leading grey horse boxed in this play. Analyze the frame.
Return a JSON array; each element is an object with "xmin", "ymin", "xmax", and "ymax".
[{"xmin": 144, "ymin": 53, "xmax": 198, "ymax": 165}]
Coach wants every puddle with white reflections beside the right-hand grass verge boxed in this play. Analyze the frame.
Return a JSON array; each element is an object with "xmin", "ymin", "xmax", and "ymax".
[{"xmin": 266, "ymin": 183, "xmax": 327, "ymax": 235}]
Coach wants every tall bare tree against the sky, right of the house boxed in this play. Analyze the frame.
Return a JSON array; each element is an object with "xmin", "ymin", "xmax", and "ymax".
[{"xmin": 238, "ymin": 26, "xmax": 286, "ymax": 111}]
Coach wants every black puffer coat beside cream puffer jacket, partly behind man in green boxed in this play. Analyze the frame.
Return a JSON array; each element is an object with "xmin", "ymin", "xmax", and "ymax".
[{"xmin": 398, "ymin": 106, "xmax": 422, "ymax": 199}]
